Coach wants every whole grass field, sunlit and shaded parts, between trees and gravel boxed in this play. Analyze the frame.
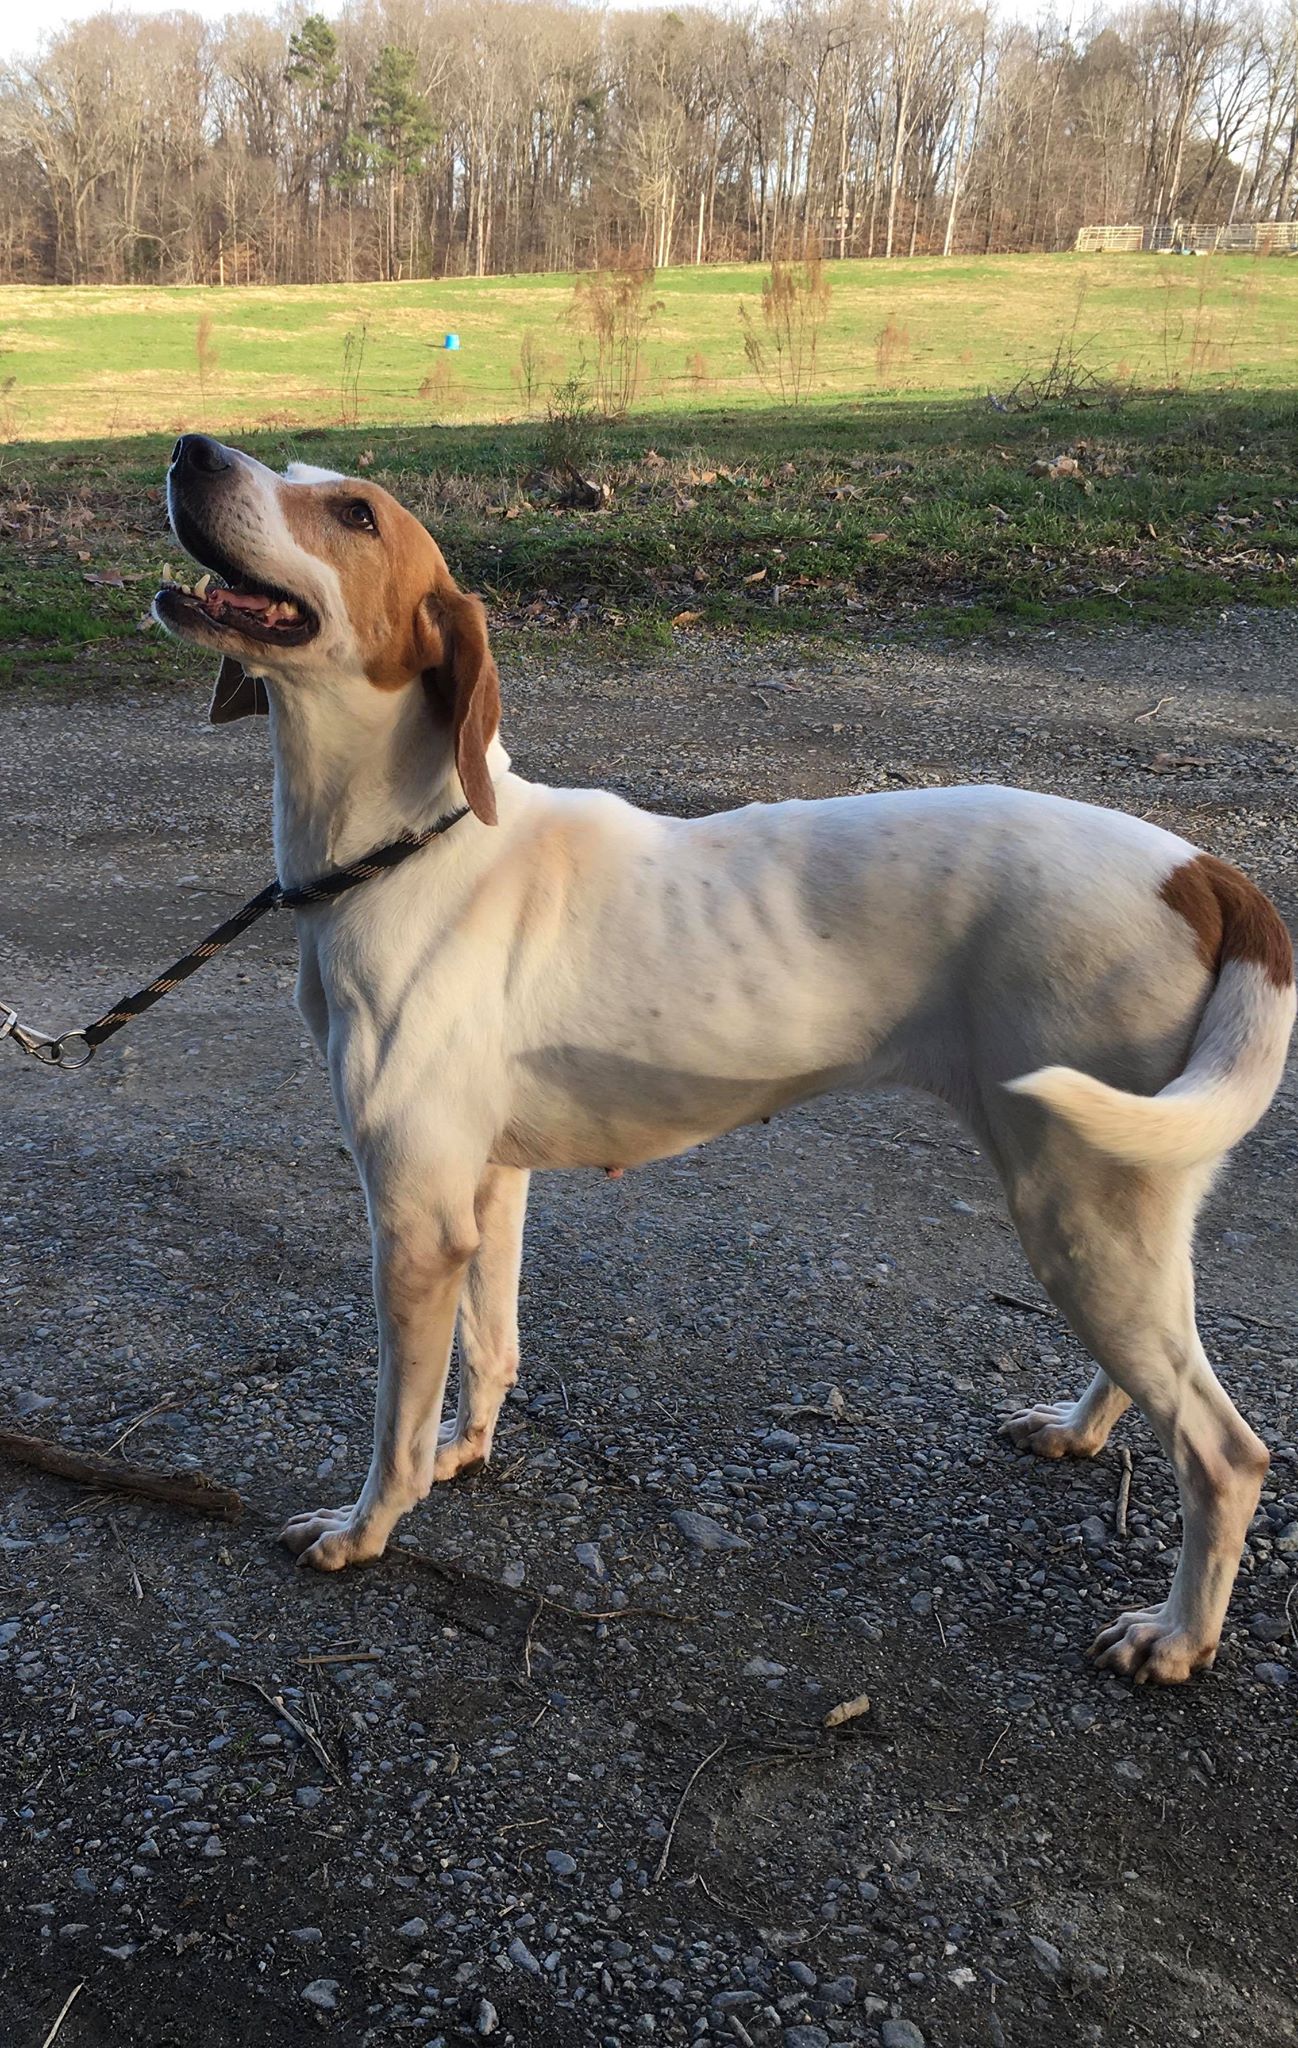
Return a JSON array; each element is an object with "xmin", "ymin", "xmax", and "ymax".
[{"xmin": 0, "ymin": 256, "xmax": 1298, "ymax": 682}]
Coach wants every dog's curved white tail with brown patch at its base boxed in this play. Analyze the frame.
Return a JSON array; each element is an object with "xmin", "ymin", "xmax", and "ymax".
[{"xmin": 1007, "ymin": 854, "xmax": 1294, "ymax": 1167}]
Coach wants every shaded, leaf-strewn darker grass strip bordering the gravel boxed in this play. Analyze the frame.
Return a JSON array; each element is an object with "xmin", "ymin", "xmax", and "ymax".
[{"xmin": 0, "ymin": 391, "xmax": 1298, "ymax": 682}]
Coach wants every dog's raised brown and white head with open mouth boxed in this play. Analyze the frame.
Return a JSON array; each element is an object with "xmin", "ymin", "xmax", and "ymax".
[{"xmin": 154, "ymin": 434, "xmax": 500, "ymax": 823}]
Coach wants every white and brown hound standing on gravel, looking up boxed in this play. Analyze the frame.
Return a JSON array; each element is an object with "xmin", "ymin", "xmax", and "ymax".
[{"xmin": 154, "ymin": 434, "xmax": 1294, "ymax": 1683}]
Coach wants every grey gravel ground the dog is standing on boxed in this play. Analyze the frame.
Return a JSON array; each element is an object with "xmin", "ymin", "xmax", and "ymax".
[{"xmin": 0, "ymin": 614, "xmax": 1298, "ymax": 2048}]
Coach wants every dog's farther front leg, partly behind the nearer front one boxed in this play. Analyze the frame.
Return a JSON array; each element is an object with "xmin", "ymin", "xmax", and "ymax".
[{"xmin": 432, "ymin": 1165, "xmax": 528, "ymax": 1481}]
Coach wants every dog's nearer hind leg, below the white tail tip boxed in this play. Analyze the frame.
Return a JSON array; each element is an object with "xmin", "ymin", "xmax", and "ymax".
[{"xmin": 997, "ymin": 1122, "xmax": 1267, "ymax": 1683}]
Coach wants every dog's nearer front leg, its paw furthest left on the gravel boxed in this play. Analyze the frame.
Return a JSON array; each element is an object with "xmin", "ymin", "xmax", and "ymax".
[{"xmin": 283, "ymin": 1184, "xmax": 477, "ymax": 1571}]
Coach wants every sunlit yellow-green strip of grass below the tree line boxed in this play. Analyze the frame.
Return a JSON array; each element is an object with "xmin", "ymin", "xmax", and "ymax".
[{"xmin": 0, "ymin": 256, "xmax": 1298, "ymax": 440}]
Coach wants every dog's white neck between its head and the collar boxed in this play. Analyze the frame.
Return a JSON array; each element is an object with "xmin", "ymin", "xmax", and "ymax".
[{"xmin": 268, "ymin": 682, "xmax": 510, "ymax": 887}]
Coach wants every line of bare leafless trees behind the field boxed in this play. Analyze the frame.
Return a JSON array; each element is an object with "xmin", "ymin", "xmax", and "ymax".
[{"xmin": 0, "ymin": 0, "xmax": 1298, "ymax": 285}]
